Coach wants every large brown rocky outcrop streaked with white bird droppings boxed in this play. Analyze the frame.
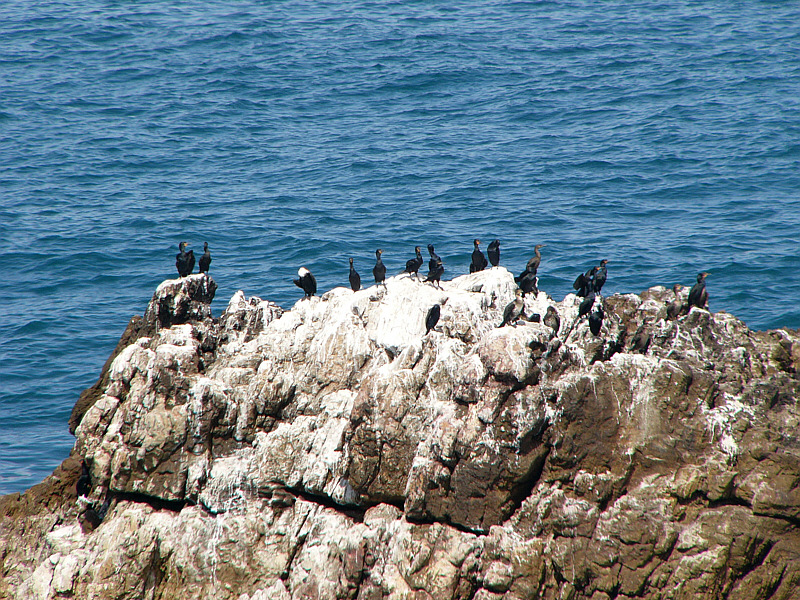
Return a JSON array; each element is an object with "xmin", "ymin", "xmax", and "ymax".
[{"xmin": 0, "ymin": 268, "xmax": 800, "ymax": 600}]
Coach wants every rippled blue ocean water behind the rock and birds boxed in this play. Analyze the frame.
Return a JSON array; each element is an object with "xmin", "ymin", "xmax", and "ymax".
[{"xmin": 0, "ymin": 0, "xmax": 800, "ymax": 493}]
